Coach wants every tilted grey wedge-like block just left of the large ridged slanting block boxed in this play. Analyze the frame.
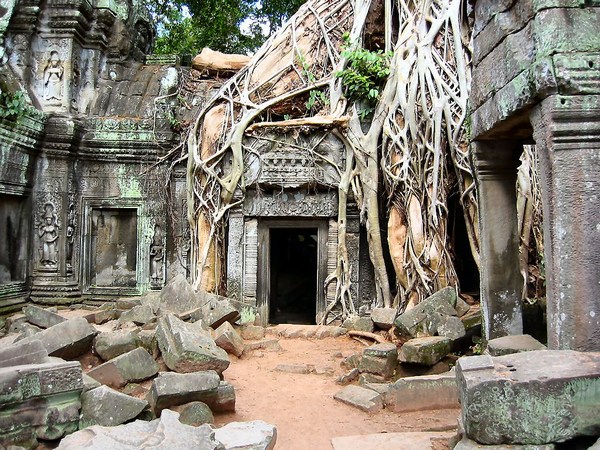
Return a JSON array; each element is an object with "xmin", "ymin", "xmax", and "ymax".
[{"xmin": 88, "ymin": 348, "xmax": 158, "ymax": 387}]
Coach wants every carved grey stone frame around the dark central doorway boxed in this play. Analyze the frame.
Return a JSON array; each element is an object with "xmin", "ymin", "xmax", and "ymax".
[{"xmin": 256, "ymin": 218, "xmax": 328, "ymax": 326}]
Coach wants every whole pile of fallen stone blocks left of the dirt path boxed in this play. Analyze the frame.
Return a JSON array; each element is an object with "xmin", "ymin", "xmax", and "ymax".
[{"xmin": 0, "ymin": 277, "xmax": 278, "ymax": 449}]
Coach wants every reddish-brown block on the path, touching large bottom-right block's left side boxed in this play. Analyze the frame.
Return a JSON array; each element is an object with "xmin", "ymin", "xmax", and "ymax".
[{"xmin": 383, "ymin": 372, "xmax": 460, "ymax": 412}]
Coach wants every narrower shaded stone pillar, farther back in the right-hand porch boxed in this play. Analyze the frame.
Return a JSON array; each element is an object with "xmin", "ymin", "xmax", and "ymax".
[{"xmin": 473, "ymin": 141, "xmax": 523, "ymax": 340}]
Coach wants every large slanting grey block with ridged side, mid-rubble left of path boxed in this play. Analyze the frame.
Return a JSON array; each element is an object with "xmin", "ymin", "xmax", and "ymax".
[{"xmin": 156, "ymin": 314, "xmax": 229, "ymax": 373}]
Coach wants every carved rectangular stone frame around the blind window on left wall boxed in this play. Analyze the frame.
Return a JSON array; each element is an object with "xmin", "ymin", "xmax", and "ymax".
[{"xmin": 80, "ymin": 198, "xmax": 150, "ymax": 296}]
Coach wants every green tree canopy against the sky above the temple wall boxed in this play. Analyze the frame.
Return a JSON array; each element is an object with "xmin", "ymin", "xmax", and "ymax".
[{"xmin": 149, "ymin": 0, "xmax": 304, "ymax": 54}]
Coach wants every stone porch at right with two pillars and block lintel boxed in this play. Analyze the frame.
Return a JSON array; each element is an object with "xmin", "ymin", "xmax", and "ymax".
[{"xmin": 470, "ymin": 0, "xmax": 600, "ymax": 351}]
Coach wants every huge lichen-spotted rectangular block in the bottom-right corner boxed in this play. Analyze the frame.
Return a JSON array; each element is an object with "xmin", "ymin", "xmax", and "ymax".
[{"xmin": 456, "ymin": 350, "xmax": 600, "ymax": 445}]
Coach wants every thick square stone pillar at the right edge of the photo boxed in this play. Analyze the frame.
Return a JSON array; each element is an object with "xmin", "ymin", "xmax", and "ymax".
[{"xmin": 531, "ymin": 95, "xmax": 600, "ymax": 351}]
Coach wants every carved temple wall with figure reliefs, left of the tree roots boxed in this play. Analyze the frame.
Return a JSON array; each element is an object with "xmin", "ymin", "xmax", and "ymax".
[{"xmin": 0, "ymin": 0, "xmax": 204, "ymax": 310}]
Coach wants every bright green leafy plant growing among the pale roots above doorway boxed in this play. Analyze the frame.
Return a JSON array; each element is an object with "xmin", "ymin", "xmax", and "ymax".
[{"xmin": 335, "ymin": 35, "xmax": 392, "ymax": 113}]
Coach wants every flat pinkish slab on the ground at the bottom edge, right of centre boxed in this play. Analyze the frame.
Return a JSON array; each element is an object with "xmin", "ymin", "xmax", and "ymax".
[{"xmin": 331, "ymin": 432, "xmax": 455, "ymax": 450}]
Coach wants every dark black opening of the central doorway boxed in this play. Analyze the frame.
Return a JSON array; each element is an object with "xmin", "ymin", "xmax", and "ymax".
[{"xmin": 269, "ymin": 228, "xmax": 319, "ymax": 324}]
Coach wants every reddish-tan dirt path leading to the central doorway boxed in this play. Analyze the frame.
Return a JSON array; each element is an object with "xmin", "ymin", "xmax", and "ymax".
[{"xmin": 215, "ymin": 336, "xmax": 459, "ymax": 450}]
